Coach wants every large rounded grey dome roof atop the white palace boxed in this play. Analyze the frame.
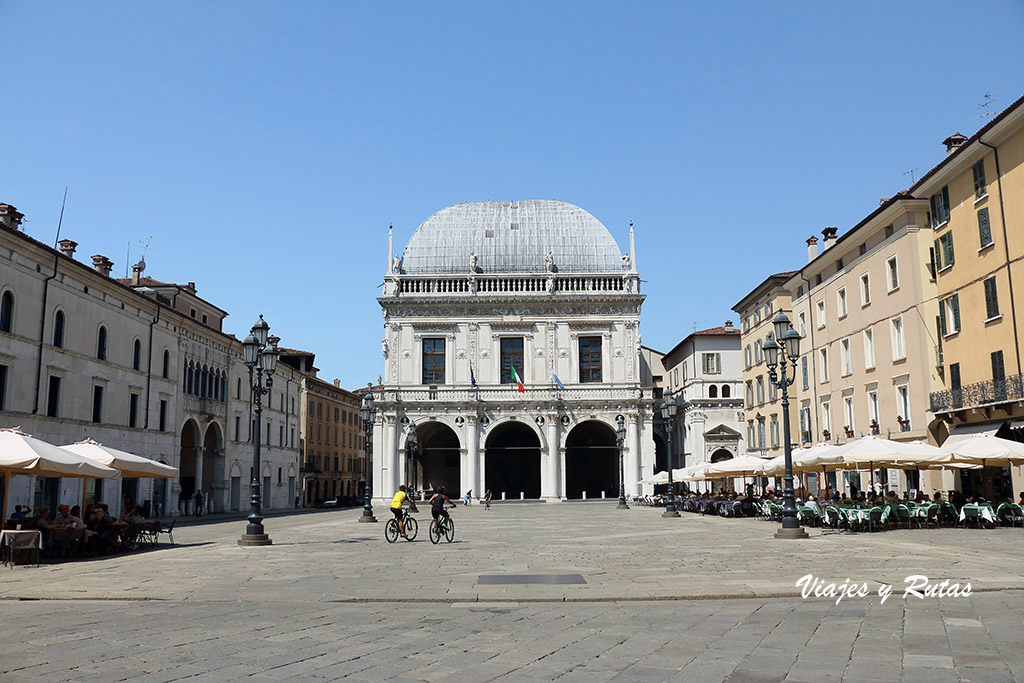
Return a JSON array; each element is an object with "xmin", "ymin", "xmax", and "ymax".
[{"xmin": 401, "ymin": 200, "xmax": 623, "ymax": 274}]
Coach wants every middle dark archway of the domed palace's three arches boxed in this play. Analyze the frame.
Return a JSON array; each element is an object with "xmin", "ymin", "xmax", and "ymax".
[{"xmin": 476, "ymin": 421, "xmax": 541, "ymax": 500}]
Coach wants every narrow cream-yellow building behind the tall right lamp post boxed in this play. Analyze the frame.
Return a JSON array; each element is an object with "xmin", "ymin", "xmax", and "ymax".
[{"xmin": 732, "ymin": 271, "xmax": 801, "ymax": 458}]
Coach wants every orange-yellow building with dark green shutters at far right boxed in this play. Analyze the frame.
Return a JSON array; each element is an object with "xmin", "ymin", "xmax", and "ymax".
[{"xmin": 910, "ymin": 93, "xmax": 1024, "ymax": 498}]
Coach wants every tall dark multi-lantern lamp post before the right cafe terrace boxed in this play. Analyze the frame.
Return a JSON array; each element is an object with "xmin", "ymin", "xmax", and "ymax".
[{"xmin": 761, "ymin": 311, "xmax": 808, "ymax": 539}]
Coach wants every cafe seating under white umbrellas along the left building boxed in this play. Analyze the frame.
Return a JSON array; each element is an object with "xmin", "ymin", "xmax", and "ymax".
[{"xmin": 0, "ymin": 429, "xmax": 178, "ymax": 565}]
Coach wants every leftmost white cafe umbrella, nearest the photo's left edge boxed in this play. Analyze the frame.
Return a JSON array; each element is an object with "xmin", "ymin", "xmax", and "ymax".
[{"xmin": 0, "ymin": 428, "xmax": 120, "ymax": 517}]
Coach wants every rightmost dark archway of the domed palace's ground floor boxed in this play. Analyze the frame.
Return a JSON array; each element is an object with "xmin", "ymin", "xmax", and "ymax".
[{"xmin": 565, "ymin": 420, "xmax": 618, "ymax": 499}]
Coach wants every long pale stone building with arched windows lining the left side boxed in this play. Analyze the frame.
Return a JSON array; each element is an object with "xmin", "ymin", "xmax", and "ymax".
[{"xmin": 0, "ymin": 204, "xmax": 298, "ymax": 514}]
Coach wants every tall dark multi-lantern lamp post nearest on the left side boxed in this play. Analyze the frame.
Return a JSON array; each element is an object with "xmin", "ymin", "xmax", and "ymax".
[{"xmin": 239, "ymin": 315, "xmax": 278, "ymax": 546}]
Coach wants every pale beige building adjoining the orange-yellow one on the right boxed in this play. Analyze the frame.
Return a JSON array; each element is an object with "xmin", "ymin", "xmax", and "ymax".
[{"xmin": 785, "ymin": 194, "xmax": 941, "ymax": 493}]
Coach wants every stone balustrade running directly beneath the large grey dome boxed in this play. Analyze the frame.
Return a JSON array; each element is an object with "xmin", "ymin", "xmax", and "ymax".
[{"xmin": 394, "ymin": 273, "xmax": 639, "ymax": 296}]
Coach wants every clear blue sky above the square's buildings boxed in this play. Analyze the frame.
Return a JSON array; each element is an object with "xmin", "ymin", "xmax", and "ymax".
[{"xmin": 0, "ymin": 0, "xmax": 1024, "ymax": 388}]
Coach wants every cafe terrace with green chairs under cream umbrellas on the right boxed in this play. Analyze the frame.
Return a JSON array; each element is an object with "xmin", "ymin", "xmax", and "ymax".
[{"xmin": 634, "ymin": 434, "xmax": 1024, "ymax": 531}]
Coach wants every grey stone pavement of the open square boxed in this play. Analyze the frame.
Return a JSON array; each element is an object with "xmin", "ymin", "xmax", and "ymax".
[{"xmin": 0, "ymin": 502, "xmax": 1024, "ymax": 683}]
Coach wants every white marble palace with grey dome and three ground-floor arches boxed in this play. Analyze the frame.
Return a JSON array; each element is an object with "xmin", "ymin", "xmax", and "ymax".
[{"xmin": 373, "ymin": 200, "xmax": 655, "ymax": 501}]
